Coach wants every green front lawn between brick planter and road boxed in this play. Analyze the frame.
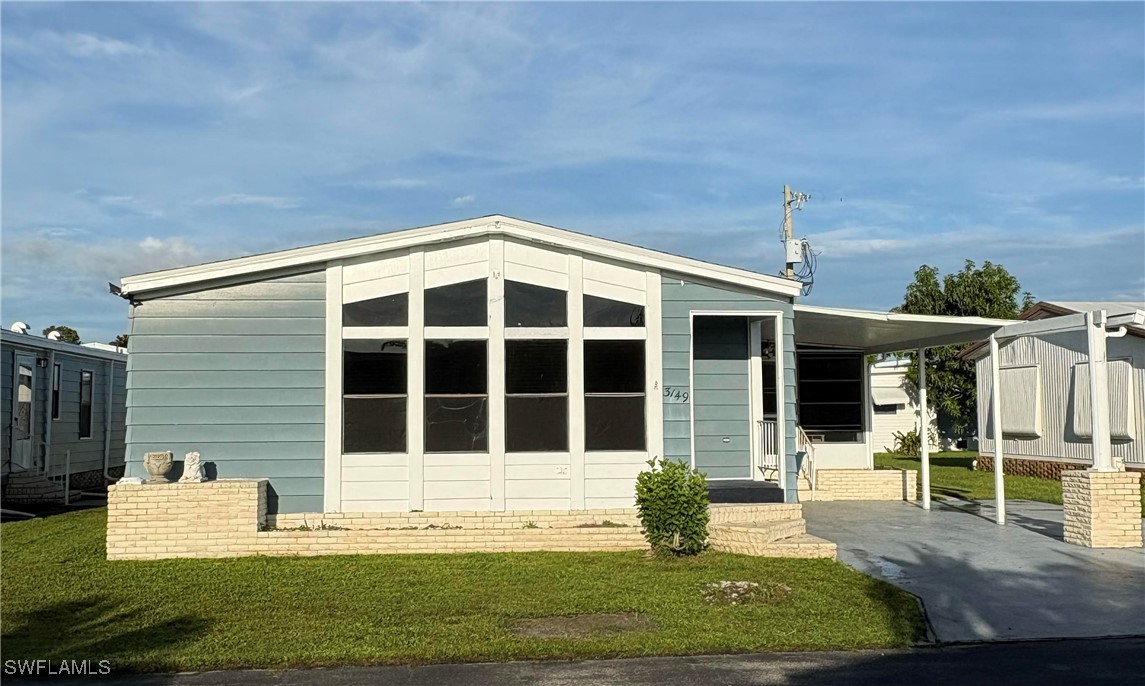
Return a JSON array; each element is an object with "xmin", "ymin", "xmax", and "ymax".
[{"xmin": 0, "ymin": 510, "xmax": 922, "ymax": 671}]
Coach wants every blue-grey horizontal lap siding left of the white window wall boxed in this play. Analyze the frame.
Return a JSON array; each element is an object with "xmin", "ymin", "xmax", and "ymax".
[{"xmin": 126, "ymin": 273, "xmax": 325, "ymax": 513}]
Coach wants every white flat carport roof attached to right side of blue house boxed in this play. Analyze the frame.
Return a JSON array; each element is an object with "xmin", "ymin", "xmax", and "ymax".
[{"xmin": 795, "ymin": 305, "xmax": 1012, "ymax": 353}]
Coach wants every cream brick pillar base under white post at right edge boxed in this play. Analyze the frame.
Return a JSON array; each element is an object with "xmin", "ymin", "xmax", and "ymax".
[{"xmin": 1061, "ymin": 470, "xmax": 1142, "ymax": 547}]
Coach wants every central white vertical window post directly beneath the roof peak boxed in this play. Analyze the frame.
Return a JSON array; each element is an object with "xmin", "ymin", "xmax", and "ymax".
[{"xmin": 485, "ymin": 238, "xmax": 505, "ymax": 512}]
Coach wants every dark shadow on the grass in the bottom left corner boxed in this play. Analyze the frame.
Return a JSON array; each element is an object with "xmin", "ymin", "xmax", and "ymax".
[{"xmin": 2, "ymin": 596, "xmax": 211, "ymax": 676}]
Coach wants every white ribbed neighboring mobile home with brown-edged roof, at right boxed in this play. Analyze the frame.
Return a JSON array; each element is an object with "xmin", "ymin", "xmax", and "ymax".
[{"xmin": 962, "ymin": 301, "xmax": 1145, "ymax": 479}]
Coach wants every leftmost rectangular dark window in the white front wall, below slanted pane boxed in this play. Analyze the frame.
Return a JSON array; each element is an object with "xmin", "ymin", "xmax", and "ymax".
[{"xmin": 342, "ymin": 340, "xmax": 409, "ymax": 452}]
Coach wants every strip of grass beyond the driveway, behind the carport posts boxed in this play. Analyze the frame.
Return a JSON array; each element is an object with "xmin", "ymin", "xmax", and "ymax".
[{"xmin": 875, "ymin": 452, "xmax": 1145, "ymax": 511}]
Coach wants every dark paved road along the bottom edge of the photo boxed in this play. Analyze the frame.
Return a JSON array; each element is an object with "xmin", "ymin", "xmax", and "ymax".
[{"xmin": 11, "ymin": 639, "xmax": 1145, "ymax": 686}]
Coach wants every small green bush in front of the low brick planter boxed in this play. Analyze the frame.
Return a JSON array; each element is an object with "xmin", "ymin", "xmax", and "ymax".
[{"xmin": 637, "ymin": 458, "xmax": 708, "ymax": 555}]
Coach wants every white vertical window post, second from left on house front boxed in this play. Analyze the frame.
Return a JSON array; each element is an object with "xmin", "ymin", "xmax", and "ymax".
[{"xmin": 405, "ymin": 249, "xmax": 426, "ymax": 511}]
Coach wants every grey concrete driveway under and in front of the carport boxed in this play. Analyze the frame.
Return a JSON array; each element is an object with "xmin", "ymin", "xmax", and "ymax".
[{"xmin": 803, "ymin": 500, "xmax": 1145, "ymax": 641}]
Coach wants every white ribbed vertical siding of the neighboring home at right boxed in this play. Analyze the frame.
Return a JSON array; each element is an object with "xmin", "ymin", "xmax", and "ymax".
[{"xmin": 977, "ymin": 331, "xmax": 1145, "ymax": 466}]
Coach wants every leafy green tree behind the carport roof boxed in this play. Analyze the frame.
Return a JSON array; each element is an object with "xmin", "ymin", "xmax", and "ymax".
[{"xmin": 893, "ymin": 260, "xmax": 1034, "ymax": 437}]
